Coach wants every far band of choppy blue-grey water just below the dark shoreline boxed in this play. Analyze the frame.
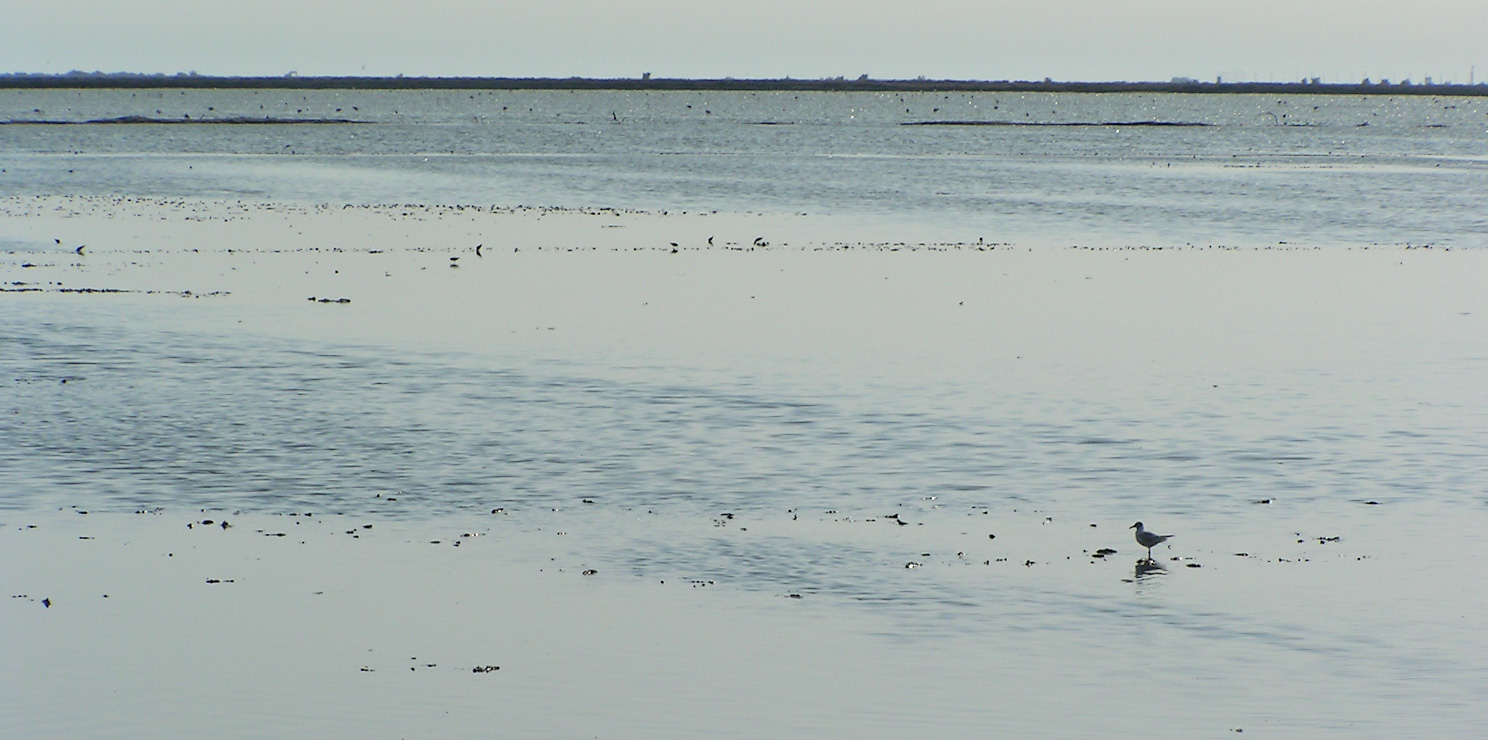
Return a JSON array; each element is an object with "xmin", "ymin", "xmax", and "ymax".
[{"xmin": 0, "ymin": 91, "xmax": 1488, "ymax": 247}]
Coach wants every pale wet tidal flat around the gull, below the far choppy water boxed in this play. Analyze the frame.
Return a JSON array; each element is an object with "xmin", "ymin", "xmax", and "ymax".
[{"xmin": 0, "ymin": 198, "xmax": 1488, "ymax": 737}]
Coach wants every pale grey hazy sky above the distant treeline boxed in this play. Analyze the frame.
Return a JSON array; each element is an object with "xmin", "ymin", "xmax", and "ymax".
[{"xmin": 0, "ymin": 0, "xmax": 1488, "ymax": 82}]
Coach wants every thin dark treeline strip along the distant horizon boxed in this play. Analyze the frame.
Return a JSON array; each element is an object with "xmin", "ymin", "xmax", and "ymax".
[{"xmin": 0, "ymin": 71, "xmax": 1488, "ymax": 97}]
